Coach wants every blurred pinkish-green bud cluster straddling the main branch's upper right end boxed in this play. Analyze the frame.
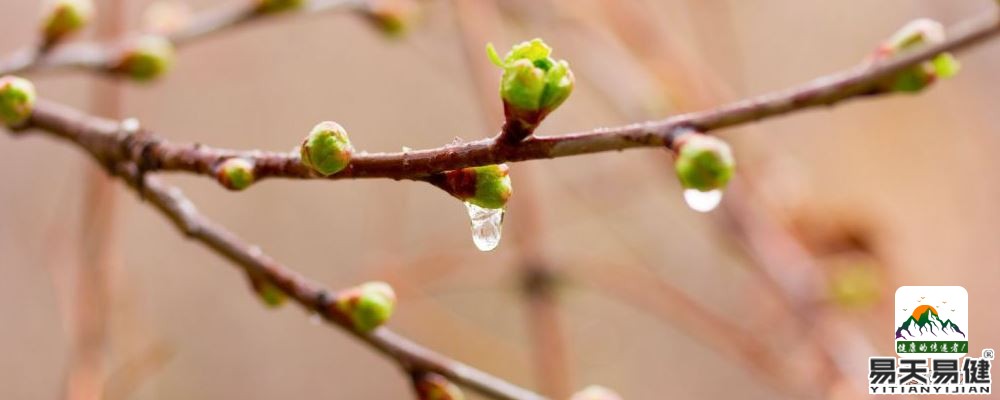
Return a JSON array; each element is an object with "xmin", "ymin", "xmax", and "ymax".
[{"xmin": 873, "ymin": 18, "xmax": 961, "ymax": 93}]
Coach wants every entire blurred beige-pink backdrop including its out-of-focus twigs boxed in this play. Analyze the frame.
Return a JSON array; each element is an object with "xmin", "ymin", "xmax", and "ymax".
[{"xmin": 0, "ymin": 0, "xmax": 1000, "ymax": 399}]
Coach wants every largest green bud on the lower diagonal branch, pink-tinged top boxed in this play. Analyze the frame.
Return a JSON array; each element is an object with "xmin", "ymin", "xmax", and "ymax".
[{"xmin": 334, "ymin": 282, "xmax": 396, "ymax": 333}]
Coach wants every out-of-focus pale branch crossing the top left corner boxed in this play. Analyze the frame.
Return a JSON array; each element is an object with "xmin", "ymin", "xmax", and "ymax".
[{"xmin": 0, "ymin": 0, "xmax": 371, "ymax": 75}]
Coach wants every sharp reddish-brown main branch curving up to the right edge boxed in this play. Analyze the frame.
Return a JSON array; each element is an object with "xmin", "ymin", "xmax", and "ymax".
[{"xmin": 15, "ymin": 10, "xmax": 1000, "ymax": 188}]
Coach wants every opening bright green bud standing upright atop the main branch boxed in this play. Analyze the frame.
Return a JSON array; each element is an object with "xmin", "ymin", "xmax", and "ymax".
[{"xmin": 486, "ymin": 39, "xmax": 574, "ymax": 127}]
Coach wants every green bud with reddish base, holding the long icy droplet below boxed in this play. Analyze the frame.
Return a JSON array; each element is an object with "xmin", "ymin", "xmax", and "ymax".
[{"xmin": 440, "ymin": 164, "xmax": 514, "ymax": 209}]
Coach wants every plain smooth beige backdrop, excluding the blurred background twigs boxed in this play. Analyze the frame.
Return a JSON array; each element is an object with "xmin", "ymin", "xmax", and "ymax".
[{"xmin": 0, "ymin": 0, "xmax": 1000, "ymax": 399}]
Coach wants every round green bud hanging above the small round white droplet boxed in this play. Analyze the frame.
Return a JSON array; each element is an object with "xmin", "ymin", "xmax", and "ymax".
[{"xmin": 674, "ymin": 133, "xmax": 735, "ymax": 192}]
